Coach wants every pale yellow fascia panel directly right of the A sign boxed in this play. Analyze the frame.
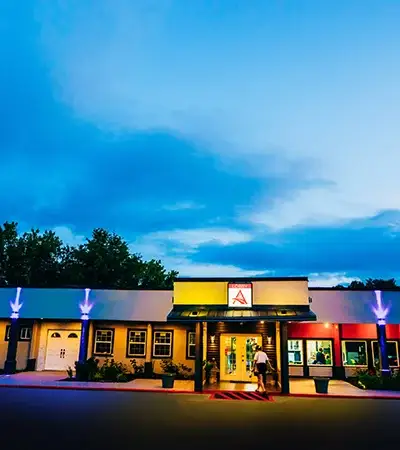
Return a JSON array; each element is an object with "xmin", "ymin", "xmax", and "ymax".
[{"xmin": 253, "ymin": 280, "xmax": 309, "ymax": 305}]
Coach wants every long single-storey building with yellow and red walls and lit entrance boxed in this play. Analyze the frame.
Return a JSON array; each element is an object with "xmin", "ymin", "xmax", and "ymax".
[{"xmin": 0, "ymin": 277, "xmax": 400, "ymax": 393}]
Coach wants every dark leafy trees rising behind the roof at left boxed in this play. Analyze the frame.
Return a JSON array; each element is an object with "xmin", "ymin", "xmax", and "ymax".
[{"xmin": 0, "ymin": 222, "xmax": 178, "ymax": 289}]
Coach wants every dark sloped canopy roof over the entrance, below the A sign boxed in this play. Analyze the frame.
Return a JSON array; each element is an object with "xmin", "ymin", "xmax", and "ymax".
[{"xmin": 167, "ymin": 305, "xmax": 317, "ymax": 322}]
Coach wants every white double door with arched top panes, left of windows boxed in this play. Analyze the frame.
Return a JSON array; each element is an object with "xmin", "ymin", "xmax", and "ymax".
[{"xmin": 44, "ymin": 330, "xmax": 81, "ymax": 370}]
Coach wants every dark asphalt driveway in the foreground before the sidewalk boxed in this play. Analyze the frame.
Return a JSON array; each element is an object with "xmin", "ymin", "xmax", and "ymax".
[{"xmin": 0, "ymin": 388, "xmax": 400, "ymax": 450}]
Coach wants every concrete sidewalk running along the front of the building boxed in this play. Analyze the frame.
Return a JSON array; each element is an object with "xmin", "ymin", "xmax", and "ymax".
[{"xmin": 0, "ymin": 372, "xmax": 400, "ymax": 400}]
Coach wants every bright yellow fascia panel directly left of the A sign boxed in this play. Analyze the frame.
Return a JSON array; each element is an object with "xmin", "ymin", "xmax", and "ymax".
[{"xmin": 174, "ymin": 281, "xmax": 228, "ymax": 305}]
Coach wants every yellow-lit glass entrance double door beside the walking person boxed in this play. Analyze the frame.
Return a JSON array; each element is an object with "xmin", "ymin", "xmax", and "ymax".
[{"xmin": 220, "ymin": 334, "xmax": 262, "ymax": 382}]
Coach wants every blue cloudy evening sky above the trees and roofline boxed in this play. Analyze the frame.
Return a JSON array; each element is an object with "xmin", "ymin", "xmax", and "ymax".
[{"xmin": 0, "ymin": 0, "xmax": 400, "ymax": 285}]
